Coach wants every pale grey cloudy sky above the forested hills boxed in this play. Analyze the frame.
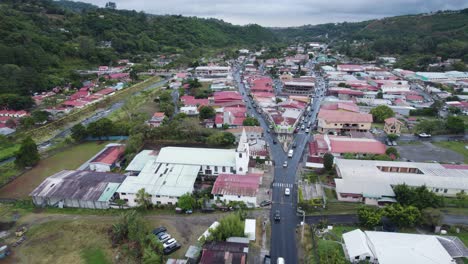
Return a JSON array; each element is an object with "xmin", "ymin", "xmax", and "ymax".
[{"xmin": 77, "ymin": 0, "xmax": 468, "ymax": 27}]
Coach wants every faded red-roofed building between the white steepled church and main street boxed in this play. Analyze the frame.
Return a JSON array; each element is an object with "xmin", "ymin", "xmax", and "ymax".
[{"xmin": 211, "ymin": 173, "xmax": 263, "ymax": 208}]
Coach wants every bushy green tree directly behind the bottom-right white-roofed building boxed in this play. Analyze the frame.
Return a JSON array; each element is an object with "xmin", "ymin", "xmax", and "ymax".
[{"xmin": 384, "ymin": 204, "xmax": 421, "ymax": 227}]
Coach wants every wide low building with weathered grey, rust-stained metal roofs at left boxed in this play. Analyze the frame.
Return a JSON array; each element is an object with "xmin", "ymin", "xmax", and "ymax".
[{"xmin": 30, "ymin": 170, "xmax": 126, "ymax": 209}]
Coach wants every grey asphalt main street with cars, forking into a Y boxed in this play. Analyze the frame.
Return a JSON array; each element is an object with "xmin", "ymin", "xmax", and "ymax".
[{"xmin": 234, "ymin": 60, "xmax": 326, "ymax": 263}]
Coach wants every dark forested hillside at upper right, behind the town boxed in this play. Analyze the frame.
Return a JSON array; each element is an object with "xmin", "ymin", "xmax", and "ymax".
[{"xmin": 273, "ymin": 9, "xmax": 468, "ymax": 69}]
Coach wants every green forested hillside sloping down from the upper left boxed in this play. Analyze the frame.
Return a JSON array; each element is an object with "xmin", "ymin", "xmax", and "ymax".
[{"xmin": 0, "ymin": 0, "xmax": 275, "ymax": 98}]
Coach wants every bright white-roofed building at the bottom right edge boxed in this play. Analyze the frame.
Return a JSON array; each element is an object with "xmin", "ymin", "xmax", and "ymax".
[{"xmin": 343, "ymin": 229, "xmax": 458, "ymax": 264}]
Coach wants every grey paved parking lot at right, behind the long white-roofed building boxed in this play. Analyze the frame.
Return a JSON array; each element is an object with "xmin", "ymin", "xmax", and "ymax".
[{"xmin": 396, "ymin": 142, "xmax": 464, "ymax": 163}]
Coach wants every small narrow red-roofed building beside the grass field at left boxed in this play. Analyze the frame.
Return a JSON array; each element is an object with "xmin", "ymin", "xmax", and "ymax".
[{"xmin": 89, "ymin": 144, "xmax": 125, "ymax": 172}]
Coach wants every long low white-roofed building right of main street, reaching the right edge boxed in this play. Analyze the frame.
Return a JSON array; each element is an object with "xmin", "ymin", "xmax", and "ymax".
[{"xmin": 335, "ymin": 159, "xmax": 468, "ymax": 205}]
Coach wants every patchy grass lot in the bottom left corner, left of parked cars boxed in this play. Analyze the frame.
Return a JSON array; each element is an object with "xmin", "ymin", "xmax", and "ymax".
[{"xmin": 7, "ymin": 219, "xmax": 113, "ymax": 264}]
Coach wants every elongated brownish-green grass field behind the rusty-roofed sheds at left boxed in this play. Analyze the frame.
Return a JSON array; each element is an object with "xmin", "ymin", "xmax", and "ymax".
[{"xmin": 0, "ymin": 142, "xmax": 109, "ymax": 199}]
